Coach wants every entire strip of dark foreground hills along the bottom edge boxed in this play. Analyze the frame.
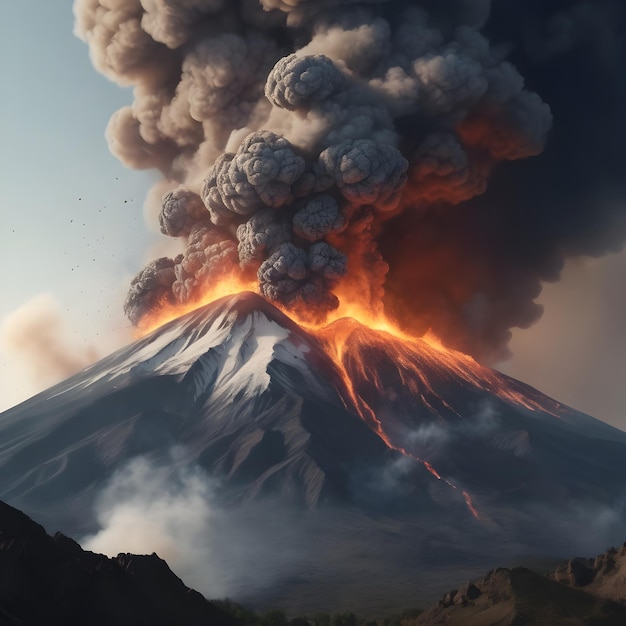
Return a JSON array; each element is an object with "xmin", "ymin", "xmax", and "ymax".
[{"xmin": 0, "ymin": 502, "xmax": 626, "ymax": 626}]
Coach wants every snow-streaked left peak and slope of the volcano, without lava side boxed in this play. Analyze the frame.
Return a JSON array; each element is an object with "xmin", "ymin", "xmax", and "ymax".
[{"xmin": 0, "ymin": 294, "xmax": 388, "ymax": 530}]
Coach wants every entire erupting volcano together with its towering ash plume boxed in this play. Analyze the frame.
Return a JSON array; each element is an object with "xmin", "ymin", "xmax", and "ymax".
[{"xmin": 0, "ymin": 0, "xmax": 626, "ymax": 609}]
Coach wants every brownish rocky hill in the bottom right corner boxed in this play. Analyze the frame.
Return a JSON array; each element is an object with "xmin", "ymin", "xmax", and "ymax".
[{"xmin": 414, "ymin": 567, "xmax": 626, "ymax": 626}]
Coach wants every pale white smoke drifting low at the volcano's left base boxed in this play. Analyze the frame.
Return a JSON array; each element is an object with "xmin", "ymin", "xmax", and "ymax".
[{"xmin": 80, "ymin": 449, "xmax": 307, "ymax": 598}]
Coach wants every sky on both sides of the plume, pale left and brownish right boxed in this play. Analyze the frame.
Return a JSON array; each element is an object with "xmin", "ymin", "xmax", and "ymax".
[{"xmin": 0, "ymin": 0, "xmax": 626, "ymax": 429}]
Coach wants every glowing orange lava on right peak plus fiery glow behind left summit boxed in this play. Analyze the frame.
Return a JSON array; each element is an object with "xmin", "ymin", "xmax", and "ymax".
[{"xmin": 134, "ymin": 286, "xmax": 560, "ymax": 519}]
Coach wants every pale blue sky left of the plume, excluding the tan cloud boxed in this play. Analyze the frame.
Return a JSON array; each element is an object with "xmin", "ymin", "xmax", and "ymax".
[{"xmin": 0, "ymin": 0, "xmax": 156, "ymax": 408}]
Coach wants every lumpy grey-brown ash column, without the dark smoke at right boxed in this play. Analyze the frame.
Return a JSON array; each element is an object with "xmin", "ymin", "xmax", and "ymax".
[{"xmin": 75, "ymin": 0, "xmax": 564, "ymax": 346}]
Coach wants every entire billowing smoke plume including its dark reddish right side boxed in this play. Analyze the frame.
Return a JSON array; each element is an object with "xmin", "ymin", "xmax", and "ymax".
[{"xmin": 75, "ymin": 0, "xmax": 626, "ymax": 359}]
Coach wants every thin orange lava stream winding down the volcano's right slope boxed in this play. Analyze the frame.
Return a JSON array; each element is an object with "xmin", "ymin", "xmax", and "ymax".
[{"xmin": 316, "ymin": 320, "xmax": 481, "ymax": 520}]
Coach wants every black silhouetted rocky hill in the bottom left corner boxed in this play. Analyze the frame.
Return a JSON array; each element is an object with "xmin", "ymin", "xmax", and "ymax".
[{"xmin": 0, "ymin": 494, "xmax": 233, "ymax": 626}]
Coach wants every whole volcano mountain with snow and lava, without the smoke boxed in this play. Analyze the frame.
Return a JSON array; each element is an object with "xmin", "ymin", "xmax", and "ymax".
[{"xmin": 0, "ymin": 292, "xmax": 626, "ymax": 609}]
